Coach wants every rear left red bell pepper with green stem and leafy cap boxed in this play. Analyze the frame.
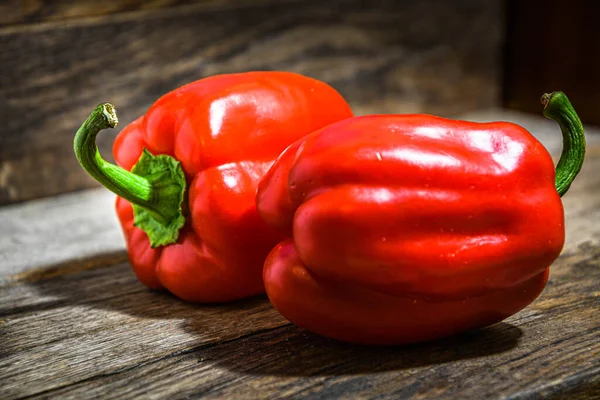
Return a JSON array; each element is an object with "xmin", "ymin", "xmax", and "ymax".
[{"xmin": 74, "ymin": 72, "xmax": 352, "ymax": 302}]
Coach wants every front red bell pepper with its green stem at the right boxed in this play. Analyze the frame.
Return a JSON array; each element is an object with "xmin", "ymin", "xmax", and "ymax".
[{"xmin": 257, "ymin": 92, "xmax": 585, "ymax": 344}]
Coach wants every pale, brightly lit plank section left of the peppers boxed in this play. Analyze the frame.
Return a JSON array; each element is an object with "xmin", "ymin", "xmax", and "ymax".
[{"xmin": 0, "ymin": 188, "xmax": 126, "ymax": 278}]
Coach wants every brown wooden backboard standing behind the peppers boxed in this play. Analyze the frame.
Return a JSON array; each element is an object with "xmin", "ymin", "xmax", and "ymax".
[{"xmin": 0, "ymin": 0, "xmax": 502, "ymax": 204}]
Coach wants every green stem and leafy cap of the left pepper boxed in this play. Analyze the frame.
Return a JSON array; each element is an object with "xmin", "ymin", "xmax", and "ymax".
[{"xmin": 73, "ymin": 103, "xmax": 186, "ymax": 247}]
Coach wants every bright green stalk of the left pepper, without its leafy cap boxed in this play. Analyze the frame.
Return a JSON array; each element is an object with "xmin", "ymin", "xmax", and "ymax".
[{"xmin": 73, "ymin": 103, "xmax": 176, "ymax": 222}]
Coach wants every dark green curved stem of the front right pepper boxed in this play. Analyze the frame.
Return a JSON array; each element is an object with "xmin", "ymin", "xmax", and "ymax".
[{"xmin": 541, "ymin": 92, "xmax": 585, "ymax": 197}]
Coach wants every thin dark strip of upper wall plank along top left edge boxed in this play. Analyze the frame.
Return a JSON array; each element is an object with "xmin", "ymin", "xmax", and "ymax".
[{"xmin": 0, "ymin": 0, "xmax": 297, "ymax": 26}]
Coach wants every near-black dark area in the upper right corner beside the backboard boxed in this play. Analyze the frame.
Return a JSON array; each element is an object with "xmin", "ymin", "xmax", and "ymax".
[{"xmin": 502, "ymin": 0, "xmax": 600, "ymax": 125}]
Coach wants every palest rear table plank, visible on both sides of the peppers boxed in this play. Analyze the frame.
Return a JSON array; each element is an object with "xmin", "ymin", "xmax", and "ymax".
[{"xmin": 0, "ymin": 109, "xmax": 600, "ymax": 278}]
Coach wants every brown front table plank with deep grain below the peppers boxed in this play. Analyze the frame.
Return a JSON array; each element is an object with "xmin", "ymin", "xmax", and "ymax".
[{"xmin": 0, "ymin": 239, "xmax": 600, "ymax": 399}]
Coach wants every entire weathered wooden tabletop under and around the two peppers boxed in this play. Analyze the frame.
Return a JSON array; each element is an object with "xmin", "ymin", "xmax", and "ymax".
[{"xmin": 0, "ymin": 110, "xmax": 600, "ymax": 399}]
